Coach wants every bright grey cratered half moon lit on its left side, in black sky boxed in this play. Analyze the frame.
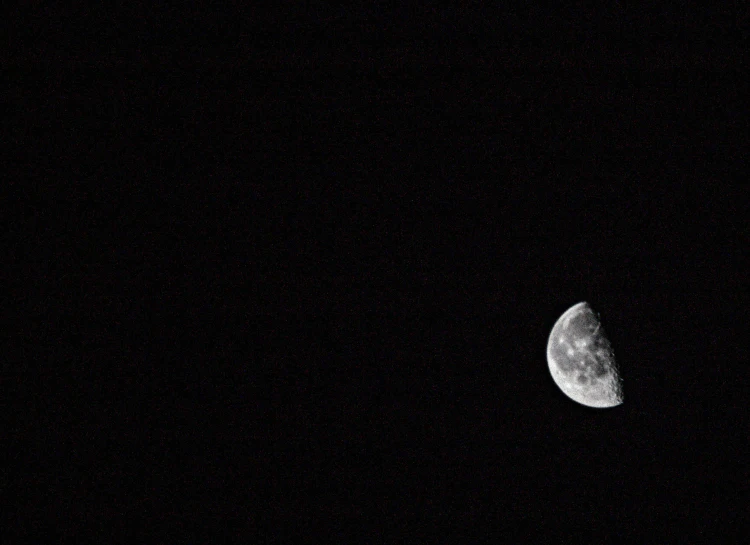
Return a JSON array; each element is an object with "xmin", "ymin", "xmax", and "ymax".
[{"xmin": 547, "ymin": 302, "xmax": 624, "ymax": 409}]
